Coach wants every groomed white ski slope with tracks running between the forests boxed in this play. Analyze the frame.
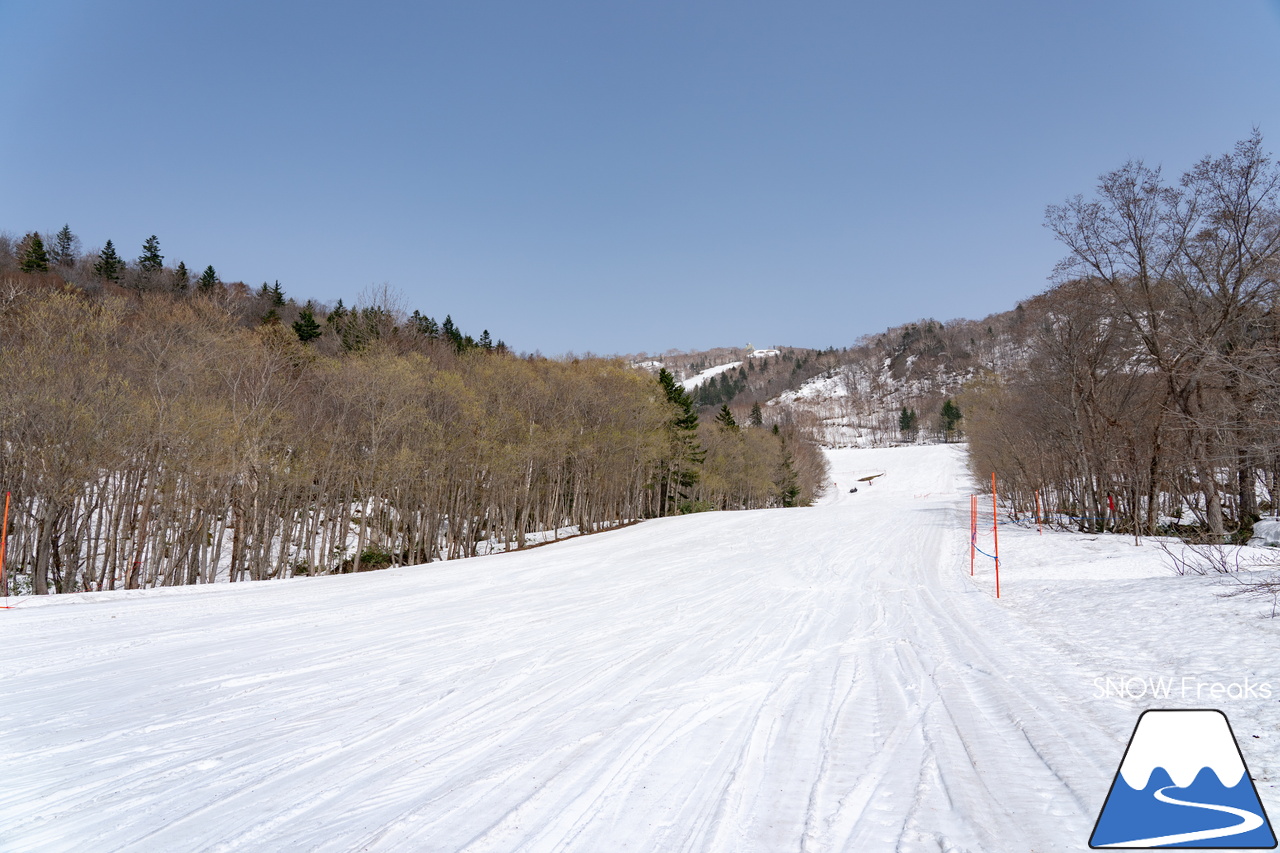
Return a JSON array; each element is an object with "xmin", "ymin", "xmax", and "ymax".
[{"xmin": 0, "ymin": 446, "xmax": 1280, "ymax": 853}]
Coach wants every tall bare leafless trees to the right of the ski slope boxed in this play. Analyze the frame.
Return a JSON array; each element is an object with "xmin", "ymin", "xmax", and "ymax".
[{"xmin": 960, "ymin": 133, "xmax": 1280, "ymax": 542}]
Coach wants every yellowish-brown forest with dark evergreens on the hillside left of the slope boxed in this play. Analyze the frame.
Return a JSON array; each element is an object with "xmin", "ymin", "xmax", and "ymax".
[{"xmin": 0, "ymin": 228, "xmax": 826, "ymax": 593}]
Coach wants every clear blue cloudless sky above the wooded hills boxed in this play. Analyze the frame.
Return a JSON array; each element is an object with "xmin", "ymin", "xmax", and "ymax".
[{"xmin": 0, "ymin": 0, "xmax": 1280, "ymax": 355}]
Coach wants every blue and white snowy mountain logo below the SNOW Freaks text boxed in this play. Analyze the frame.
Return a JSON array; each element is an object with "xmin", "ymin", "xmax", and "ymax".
[{"xmin": 1089, "ymin": 711, "xmax": 1276, "ymax": 850}]
